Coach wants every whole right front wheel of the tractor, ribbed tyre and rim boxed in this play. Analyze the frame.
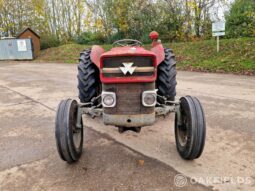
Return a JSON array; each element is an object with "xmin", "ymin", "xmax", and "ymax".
[{"xmin": 175, "ymin": 96, "xmax": 206, "ymax": 160}]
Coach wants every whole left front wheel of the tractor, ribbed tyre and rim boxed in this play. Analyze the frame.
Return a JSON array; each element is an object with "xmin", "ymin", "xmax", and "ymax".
[{"xmin": 55, "ymin": 99, "xmax": 83, "ymax": 163}]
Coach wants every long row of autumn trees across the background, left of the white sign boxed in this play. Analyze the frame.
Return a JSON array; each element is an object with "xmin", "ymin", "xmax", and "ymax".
[{"xmin": 0, "ymin": 0, "xmax": 230, "ymax": 47}]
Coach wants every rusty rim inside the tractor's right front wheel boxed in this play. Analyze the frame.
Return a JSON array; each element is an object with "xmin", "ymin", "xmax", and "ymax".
[{"xmin": 177, "ymin": 111, "xmax": 188, "ymax": 147}]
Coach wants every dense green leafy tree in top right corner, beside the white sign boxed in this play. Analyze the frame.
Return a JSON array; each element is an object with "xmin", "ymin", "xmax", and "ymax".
[{"xmin": 226, "ymin": 0, "xmax": 255, "ymax": 38}]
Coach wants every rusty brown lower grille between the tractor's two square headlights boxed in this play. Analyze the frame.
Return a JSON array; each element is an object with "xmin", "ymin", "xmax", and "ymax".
[{"xmin": 103, "ymin": 82, "xmax": 155, "ymax": 115}]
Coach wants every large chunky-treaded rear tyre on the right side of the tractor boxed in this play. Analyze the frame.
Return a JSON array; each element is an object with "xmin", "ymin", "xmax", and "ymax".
[{"xmin": 156, "ymin": 48, "xmax": 177, "ymax": 103}]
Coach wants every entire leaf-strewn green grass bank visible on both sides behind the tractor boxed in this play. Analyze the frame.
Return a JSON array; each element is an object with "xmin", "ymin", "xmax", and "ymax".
[{"xmin": 35, "ymin": 38, "xmax": 255, "ymax": 75}]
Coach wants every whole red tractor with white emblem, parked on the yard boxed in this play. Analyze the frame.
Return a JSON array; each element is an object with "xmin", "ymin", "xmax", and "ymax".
[{"xmin": 55, "ymin": 32, "xmax": 206, "ymax": 163}]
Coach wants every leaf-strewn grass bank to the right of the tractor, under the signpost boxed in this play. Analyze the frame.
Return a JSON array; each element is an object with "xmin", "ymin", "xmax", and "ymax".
[{"xmin": 170, "ymin": 38, "xmax": 255, "ymax": 75}]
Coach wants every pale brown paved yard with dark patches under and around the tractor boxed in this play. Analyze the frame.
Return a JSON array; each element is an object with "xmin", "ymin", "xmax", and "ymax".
[{"xmin": 0, "ymin": 62, "xmax": 255, "ymax": 191}]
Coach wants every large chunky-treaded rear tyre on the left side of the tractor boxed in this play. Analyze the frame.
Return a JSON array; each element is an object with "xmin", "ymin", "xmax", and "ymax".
[{"xmin": 77, "ymin": 50, "xmax": 101, "ymax": 103}]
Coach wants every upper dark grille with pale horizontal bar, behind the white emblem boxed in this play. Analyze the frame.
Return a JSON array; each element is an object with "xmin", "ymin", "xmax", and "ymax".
[{"xmin": 102, "ymin": 56, "xmax": 155, "ymax": 77}]
